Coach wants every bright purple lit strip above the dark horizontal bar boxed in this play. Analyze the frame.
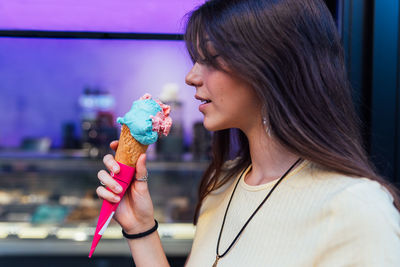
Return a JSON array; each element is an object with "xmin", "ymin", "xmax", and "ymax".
[{"xmin": 0, "ymin": 0, "xmax": 204, "ymax": 33}]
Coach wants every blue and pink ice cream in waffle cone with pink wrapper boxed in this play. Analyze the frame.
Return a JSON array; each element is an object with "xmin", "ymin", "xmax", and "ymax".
[{"xmin": 89, "ymin": 94, "xmax": 172, "ymax": 258}]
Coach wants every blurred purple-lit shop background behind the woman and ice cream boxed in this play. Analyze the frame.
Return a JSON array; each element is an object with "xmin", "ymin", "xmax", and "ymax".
[{"xmin": 0, "ymin": 0, "xmax": 400, "ymax": 267}]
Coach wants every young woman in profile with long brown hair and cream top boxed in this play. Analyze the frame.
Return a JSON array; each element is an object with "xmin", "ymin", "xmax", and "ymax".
[{"xmin": 97, "ymin": 0, "xmax": 400, "ymax": 267}]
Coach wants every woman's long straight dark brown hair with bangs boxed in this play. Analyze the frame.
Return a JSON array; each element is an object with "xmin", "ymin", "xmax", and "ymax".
[{"xmin": 184, "ymin": 0, "xmax": 400, "ymax": 223}]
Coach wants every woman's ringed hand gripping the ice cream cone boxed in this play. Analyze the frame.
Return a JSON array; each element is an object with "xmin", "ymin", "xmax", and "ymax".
[{"xmin": 96, "ymin": 141, "xmax": 154, "ymax": 234}]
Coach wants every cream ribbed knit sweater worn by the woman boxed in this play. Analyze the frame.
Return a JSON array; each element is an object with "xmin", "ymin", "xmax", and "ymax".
[{"xmin": 186, "ymin": 161, "xmax": 400, "ymax": 267}]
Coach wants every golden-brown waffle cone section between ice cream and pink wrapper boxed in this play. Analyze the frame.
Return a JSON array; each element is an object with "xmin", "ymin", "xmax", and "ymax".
[{"xmin": 115, "ymin": 124, "xmax": 148, "ymax": 167}]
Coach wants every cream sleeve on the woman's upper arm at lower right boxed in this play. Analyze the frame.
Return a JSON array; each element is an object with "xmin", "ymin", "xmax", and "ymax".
[{"xmin": 314, "ymin": 178, "xmax": 400, "ymax": 267}]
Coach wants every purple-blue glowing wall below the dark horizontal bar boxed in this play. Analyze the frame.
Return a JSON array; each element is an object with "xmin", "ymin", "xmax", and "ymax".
[{"xmin": 0, "ymin": 38, "xmax": 202, "ymax": 147}]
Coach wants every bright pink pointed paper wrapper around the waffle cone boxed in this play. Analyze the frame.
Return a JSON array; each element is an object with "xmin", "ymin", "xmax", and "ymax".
[{"xmin": 89, "ymin": 162, "xmax": 135, "ymax": 258}]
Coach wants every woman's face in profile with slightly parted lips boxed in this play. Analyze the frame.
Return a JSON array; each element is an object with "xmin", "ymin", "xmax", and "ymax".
[{"xmin": 186, "ymin": 59, "xmax": 261, "ymax": 131}]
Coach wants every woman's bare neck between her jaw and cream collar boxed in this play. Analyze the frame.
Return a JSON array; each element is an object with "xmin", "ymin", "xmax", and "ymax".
[{"xmin": 241, "ymin": 124, "xmax": 299, "ymax": 185}]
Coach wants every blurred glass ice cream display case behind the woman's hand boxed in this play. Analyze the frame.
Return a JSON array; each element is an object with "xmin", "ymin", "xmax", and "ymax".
[{"xmin": 0, "ymin": 151, "xmax": 207, "ymax": 258}]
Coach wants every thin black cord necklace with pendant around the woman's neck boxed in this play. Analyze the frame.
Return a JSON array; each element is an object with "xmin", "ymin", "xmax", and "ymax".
[{"xmin": 212, "ymin": 158, "xmax": 301, "ymax": 267}]
